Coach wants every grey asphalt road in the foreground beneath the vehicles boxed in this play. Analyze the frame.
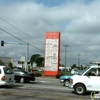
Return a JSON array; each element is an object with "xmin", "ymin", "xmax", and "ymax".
[{"xmin": 0, "ymin": 77, "xmax": 91, "ymax": 100}]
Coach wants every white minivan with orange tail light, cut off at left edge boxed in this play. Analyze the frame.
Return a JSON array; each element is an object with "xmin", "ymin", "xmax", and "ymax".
[{"xmin": 0, "ymin": 65, "xmax": 15, "ymax": 86}]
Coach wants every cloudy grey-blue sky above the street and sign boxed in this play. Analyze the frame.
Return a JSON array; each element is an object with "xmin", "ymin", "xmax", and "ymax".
[{"xmin": 0, "ymin": 0, "xmax": 100, "ymax": 66}]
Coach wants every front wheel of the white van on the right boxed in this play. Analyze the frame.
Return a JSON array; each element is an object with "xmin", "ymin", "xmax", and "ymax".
[{"xmin": 74, "ymin": 84, "xmax": 86, "ymax": 95}]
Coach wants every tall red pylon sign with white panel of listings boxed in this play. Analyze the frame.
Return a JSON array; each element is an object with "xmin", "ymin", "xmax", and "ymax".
[{"xmin": 44, "ymin": 32, "xmax": 60, "ymax": 76}]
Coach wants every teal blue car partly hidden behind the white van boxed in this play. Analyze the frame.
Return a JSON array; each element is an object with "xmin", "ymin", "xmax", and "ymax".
[{"xmin": 60, "ymin": 70, "xmax": 82, "ymax": 86}]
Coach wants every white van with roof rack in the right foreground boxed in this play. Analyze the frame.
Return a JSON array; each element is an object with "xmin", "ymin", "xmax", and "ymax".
[{"xmin": 68, "ymin": 65, "xmax": 100, "ymax": 95}]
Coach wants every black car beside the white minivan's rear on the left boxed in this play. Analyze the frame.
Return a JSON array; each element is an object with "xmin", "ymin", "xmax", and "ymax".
[{"xmin": 13, "ymin": 68, "xmax": 35, "ymax": 83}]
